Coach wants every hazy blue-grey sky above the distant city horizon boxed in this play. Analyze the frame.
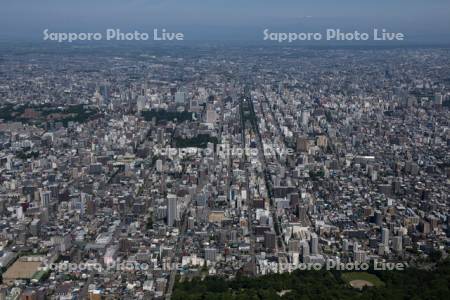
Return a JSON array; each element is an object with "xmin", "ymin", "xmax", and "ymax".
[{"xmin": 0, "ymin": 0, "xmax": 450, "ymax": 42}]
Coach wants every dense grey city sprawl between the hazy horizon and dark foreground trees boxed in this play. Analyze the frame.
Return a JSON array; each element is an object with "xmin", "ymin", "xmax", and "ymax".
[{"xmin": 0, "ymin": 43, "xmax": 450, "ymax": 299}]
